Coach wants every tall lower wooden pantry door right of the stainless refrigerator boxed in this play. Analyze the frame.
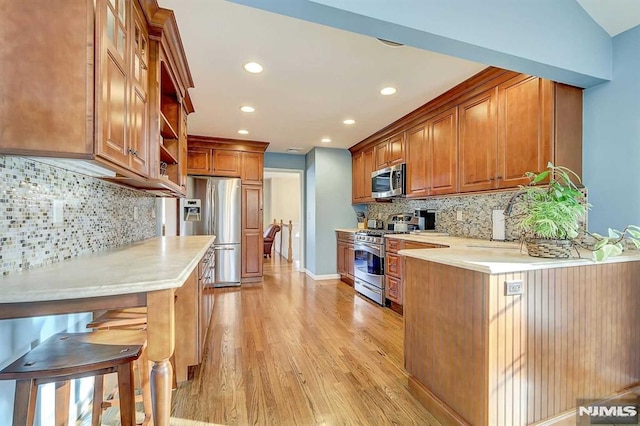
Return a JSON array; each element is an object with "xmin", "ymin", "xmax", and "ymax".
[{"xmin": 242, "ymin": 185, "xmax": 263, "ymax": 282}]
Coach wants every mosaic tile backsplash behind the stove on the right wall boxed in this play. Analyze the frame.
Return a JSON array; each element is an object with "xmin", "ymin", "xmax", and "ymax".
[{"xmin": 366, "ymin": 190, "xmax": 518, "ymax": 240}]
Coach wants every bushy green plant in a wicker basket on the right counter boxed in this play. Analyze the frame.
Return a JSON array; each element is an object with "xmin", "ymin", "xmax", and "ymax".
[{"xmin": 505, "ymin": 163, "xmax": 589, "ymax": 258}]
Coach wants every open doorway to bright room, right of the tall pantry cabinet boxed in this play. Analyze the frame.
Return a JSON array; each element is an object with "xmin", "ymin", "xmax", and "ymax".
[{"xmin": 263, "ymin": 168, "xmax": 304, "ymax": 269}]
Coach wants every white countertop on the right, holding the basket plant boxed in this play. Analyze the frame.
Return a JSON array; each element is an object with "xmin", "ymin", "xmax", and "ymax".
[{"xmin": 386, "ymin": 234, "xmax": 640, "ymax": 274}]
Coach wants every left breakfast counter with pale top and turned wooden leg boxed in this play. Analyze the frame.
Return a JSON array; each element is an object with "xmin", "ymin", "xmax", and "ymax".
[{"xmin": 0, "ymin": 236, "xmax": 215, "ymax": 425}]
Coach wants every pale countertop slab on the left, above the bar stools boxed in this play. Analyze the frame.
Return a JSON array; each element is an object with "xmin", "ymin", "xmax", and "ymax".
[{"xmin": 0, "ymin": 235, "xmax": 215, "ymax": 303}]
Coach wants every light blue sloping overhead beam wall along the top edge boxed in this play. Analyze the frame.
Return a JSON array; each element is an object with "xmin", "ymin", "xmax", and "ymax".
[{"xmin": 231, "ymin": 0, "xmax": 611, "ymax": 87}]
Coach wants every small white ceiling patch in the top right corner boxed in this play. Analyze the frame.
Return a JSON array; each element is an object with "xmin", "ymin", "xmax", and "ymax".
[{"xmin": 577, "ymin": 0, "xmax": 640, "ymax": 37}]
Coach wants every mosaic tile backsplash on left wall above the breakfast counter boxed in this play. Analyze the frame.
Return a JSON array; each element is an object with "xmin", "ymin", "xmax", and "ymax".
[{"xmin": 0, "ymin": 155, "xmax": 156, "ymax": 275}]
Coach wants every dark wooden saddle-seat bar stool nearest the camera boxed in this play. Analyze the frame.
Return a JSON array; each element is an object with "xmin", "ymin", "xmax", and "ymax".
[{"xmin": 0, "ymin": 332, "xmax": 143, "ymax": 426}]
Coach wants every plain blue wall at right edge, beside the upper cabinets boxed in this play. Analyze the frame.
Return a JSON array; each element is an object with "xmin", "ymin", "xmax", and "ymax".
[{"xmin": 583, "ymin": 26, "xmax": 640, "ymax": 232}]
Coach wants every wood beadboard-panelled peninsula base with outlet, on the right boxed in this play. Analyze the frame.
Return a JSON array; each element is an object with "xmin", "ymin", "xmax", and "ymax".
[{"xmin": 401, "ymin": 249, "xmax": 640, "ymax": 426}]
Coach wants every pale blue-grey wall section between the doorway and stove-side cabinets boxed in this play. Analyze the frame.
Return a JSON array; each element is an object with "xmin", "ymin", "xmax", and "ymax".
[{"xmin": 305, "ymin": 148, "xmax": 356, "ymax": 275}]
